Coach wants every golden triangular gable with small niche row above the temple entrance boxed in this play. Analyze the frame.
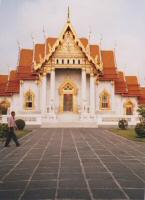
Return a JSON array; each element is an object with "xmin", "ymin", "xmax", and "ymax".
[{"xmin": 38, "ymin": 21, "xmax": 100, "ymax": 74}]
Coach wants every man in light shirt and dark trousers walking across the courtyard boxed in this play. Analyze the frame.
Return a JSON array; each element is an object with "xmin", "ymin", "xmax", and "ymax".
[{"xmin": 5, "ymin": 111, "xmax": 20, "ymax": 147}]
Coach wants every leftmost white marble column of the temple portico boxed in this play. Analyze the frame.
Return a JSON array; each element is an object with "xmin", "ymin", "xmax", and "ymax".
[{"xmin": 41, "ymin": 74, "xmax": 47, "ymax": 113}]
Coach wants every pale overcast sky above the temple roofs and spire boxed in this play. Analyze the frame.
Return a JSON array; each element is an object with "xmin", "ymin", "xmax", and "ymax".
[{"xmin": 0, "ymin": 0, "xmax": 145, "ymax": 84}]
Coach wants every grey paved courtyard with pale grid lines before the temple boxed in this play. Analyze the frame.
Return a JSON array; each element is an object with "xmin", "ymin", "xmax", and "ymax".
[{"xmin": 0, "ymin": 128, "xmax": 145, "ymax": 200}]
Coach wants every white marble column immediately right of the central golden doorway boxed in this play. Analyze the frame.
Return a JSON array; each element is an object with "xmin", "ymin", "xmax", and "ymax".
[{"xmin": 81, "ymin": 68, "xmax": 87, "ymax": 112}]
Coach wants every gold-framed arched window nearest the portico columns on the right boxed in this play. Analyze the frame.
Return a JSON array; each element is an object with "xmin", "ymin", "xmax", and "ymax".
[{"xmin": 100, "ymin": 91, "xmax": 110, "ymax": 110}]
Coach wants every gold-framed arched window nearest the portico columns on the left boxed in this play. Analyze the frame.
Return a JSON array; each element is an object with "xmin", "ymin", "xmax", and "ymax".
[{"xmin": 24, "ymin": 90, "xmax": 35, "ymax": 110}]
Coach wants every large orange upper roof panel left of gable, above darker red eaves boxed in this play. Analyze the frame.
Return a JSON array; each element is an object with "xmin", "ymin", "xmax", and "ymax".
[{"xmin": 19, "ymin": 49, "xmax": 33, "ymax": 66}]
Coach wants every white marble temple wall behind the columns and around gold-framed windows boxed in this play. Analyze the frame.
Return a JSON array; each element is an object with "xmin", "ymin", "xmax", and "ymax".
[{"xmin": 0, "ymin": 69, "xmax": 138, "ymax": 122}]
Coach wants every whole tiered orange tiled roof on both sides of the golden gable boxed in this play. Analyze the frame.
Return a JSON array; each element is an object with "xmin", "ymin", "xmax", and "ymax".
[{"xmin": 0, "ymin": 29, "xmax": 145, "ymax": 103}]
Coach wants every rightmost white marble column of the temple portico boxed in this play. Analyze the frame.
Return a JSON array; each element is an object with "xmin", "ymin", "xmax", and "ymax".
[{"xmin": 90, "ymin": 74, "xmax": 95, "ymax": 114}]
